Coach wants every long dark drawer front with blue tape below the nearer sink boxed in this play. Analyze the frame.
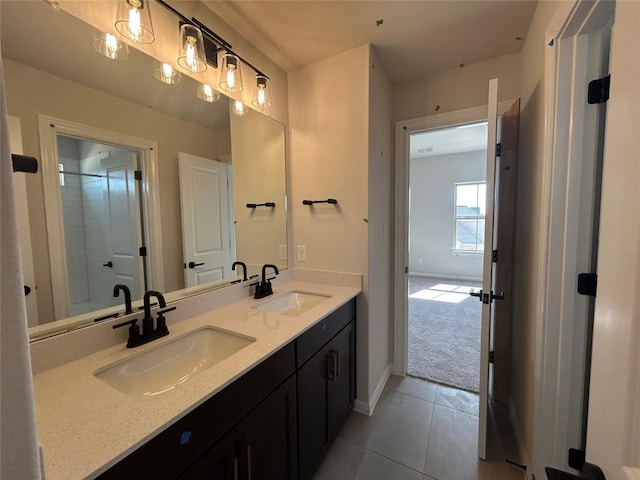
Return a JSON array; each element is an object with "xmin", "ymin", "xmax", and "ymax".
[{"xmin": 98, "ymin": 342, "xmax": 295, "ymax": 480}]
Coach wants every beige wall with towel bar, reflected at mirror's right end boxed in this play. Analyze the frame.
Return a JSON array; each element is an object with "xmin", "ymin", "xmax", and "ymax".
[{"xmin": 231, "ymin": 110, "xmax": 287, "ymax": 275}]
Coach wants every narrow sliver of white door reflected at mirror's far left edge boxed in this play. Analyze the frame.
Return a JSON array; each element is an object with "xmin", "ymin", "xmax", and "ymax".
[{"xmin": 7, "ymin": 116, "xmax": 38, "ymax": 327}]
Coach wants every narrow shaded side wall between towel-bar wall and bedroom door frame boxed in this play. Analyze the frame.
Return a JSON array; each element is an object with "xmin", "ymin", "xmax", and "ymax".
[{"xmin": 367, "ymin": 49, "xmax": 394, "ymax": 398}]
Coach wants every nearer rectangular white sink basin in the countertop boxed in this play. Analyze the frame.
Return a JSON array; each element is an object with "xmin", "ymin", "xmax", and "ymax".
[{"xmin": 94, "ymin": 327, "xmax": 256, "ymax": 398}]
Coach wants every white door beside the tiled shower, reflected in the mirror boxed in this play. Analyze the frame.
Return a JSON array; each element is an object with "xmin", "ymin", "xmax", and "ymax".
[{"xmin": 101, "ymin": 152, "xmax": 144, "ymax": 304}]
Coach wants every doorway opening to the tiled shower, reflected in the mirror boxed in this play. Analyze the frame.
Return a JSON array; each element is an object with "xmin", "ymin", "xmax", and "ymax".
[{"xmin": 57, "ymin": 134, "xmax": 146, "ymax": 316}]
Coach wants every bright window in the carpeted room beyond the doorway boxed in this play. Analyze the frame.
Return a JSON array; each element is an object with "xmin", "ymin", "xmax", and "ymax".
[{"xmin": 453, "ymin": 182, "xmax": 487, "ymax": 252}]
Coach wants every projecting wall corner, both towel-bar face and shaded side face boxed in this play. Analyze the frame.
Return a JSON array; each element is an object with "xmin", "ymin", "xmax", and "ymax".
[{"xmin": 289, "ymin": 45, "xmax": 392, "ymax": 403}]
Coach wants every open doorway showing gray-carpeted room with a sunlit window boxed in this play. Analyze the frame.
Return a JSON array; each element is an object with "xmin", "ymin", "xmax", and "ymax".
[{"xmin": 407, "ymin": 122, "xmax": 487, "ymax": 393}]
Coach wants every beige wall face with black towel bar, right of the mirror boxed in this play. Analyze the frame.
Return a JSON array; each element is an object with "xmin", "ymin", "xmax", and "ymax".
[{"xmin": 289, "ymin": 45, "xmax": 370, "ymax": 400}]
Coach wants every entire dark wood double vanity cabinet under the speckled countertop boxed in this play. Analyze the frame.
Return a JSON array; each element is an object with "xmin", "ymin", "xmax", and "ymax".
[{"xmin": 98, "ymin": 300, "xmax": 356, "ymax": 480}]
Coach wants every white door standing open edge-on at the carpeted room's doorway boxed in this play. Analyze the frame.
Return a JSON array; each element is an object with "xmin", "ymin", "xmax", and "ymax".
[{"xmin": 478, "ymin": 78, "xmax": 498, "ymax": 459}]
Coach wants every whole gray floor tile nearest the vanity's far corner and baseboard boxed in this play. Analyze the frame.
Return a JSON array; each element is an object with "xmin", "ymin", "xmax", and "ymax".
[{"xmin": 366, "ymin": 392, "xmax": 433, "ymax": 471}]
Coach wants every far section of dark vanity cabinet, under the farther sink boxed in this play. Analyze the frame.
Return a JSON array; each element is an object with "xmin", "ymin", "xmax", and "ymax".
[{"xmin": 297, "ymin": 302, "xmax": 356, "ymax": 479}]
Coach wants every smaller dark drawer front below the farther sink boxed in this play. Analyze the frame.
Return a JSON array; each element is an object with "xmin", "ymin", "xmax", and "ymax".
[{"xmin": 296, "ymin": 300, "xmax": 356, "ymax": 367}]
